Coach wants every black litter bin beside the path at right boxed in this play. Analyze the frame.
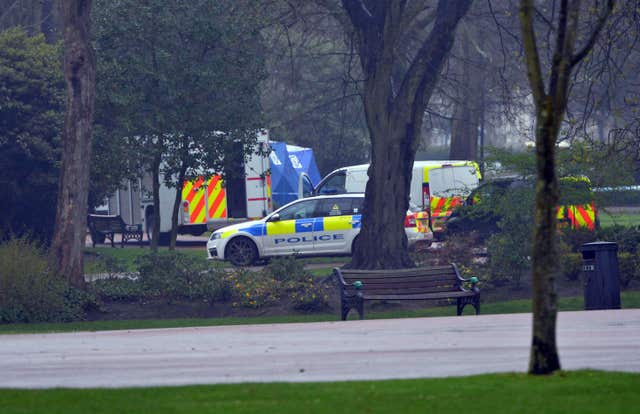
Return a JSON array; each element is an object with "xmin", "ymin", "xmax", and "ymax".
[{"xmin": 580, "ymin": 242, "xmax": 620, "ymax": 310}]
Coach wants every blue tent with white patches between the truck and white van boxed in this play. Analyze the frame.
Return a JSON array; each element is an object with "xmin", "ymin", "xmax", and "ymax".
[{"xmin": 269, "ymin": 141, "xmax": 321, "ymax": 208}]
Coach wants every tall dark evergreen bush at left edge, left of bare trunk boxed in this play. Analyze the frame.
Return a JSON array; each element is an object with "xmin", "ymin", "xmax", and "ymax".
[{"xmin": 0, "ymin": 29, "xmax": 64, "ymax": 241}]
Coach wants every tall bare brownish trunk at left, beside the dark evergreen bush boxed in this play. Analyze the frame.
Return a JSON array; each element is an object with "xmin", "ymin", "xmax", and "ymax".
[{"xmin": 51, "ymin": 0, "xmax": 95, "ymax": 287}]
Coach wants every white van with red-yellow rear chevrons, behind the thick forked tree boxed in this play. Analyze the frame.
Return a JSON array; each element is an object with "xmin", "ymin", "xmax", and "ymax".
[{"xmin": 314, "ymin": 160, "xmax": 481, "ymax": 232}]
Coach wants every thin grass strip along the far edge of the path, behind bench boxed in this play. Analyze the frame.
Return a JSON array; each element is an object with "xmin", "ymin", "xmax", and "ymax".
[{"xmin": 0, "ymin": 291, "xmax": 640, "ymax": 334}]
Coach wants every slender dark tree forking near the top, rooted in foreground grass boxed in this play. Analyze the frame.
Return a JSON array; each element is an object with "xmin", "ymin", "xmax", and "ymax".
[{"xmin": 520, "ymin": 0, "xmax": 614, "ymax": 374}]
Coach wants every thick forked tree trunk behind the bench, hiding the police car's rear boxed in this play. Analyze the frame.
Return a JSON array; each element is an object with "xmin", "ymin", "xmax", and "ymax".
[{"xmin": 342, "ymin": 0, "xmax": 472, "ymax": 268}]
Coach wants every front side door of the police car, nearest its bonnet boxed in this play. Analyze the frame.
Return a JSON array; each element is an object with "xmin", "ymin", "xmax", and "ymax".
[{"xmin": 263, "ymin": 200, "xmax": 318, "ymax": 256}]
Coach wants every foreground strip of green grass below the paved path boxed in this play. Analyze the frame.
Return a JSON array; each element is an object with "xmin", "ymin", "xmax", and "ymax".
[{"xmin": 0, "ymin": 371, "xmax": 640, "ymax": 414}]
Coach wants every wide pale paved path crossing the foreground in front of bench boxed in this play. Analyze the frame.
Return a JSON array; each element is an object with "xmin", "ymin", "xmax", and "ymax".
[{"xmin": 0, "ymin": 309, "xmax": 640, "ymax": 388}]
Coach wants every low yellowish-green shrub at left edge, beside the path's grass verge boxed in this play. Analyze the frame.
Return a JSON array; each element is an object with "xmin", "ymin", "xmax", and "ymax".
[{"xmin": 0, "ymin": 238, "xmax": 94, "ymax": 323}]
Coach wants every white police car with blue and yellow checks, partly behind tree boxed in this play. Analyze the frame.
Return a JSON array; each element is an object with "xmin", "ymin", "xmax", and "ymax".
[{"xmin": 207, "ymin": 194, "xmax": 432, "ymax": 266}]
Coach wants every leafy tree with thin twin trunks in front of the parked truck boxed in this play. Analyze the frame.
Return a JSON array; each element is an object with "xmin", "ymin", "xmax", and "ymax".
[{"xmin": 95, "ymin": 0, "xmax": 265, "ymax": 248}]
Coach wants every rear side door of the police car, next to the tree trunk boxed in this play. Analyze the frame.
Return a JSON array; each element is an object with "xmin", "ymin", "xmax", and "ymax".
[{"xmin": 314, "ymin": 197, "xmax": 362, "ymax": 254}]
